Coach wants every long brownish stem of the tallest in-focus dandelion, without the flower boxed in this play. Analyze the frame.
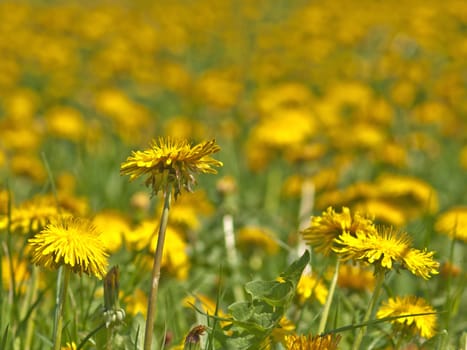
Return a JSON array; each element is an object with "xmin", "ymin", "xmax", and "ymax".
[{"xmin": 144, "ymin": 184, "xmax": 172, "ymax": 350}]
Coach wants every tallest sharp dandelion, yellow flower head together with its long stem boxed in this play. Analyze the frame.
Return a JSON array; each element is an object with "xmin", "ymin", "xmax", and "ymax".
[{"xmin": 120, "ymin": 137, "xmax": 222, "ymax": 350}]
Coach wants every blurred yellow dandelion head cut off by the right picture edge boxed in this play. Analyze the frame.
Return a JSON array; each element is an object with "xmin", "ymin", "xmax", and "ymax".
[{"xmin": 435, "ymin": 207, "xmax": 467, "ymax": 242}]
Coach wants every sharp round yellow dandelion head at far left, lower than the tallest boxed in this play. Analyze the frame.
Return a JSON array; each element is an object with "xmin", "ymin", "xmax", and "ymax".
[{"xmin": 28, "ymin": 217, "xmax": 107, "ymax": 279}]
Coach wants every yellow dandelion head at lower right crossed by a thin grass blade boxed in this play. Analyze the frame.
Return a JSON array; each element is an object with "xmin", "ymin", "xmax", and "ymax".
[{"xmin": 376, "ymin": 296, "xmax": 436, "ymax": 339}]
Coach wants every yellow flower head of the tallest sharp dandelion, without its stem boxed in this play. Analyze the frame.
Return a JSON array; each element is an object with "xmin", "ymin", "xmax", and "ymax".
[{"xmin": 120, "ymin": 137, "xmax": 223, "ymax": 198}]
